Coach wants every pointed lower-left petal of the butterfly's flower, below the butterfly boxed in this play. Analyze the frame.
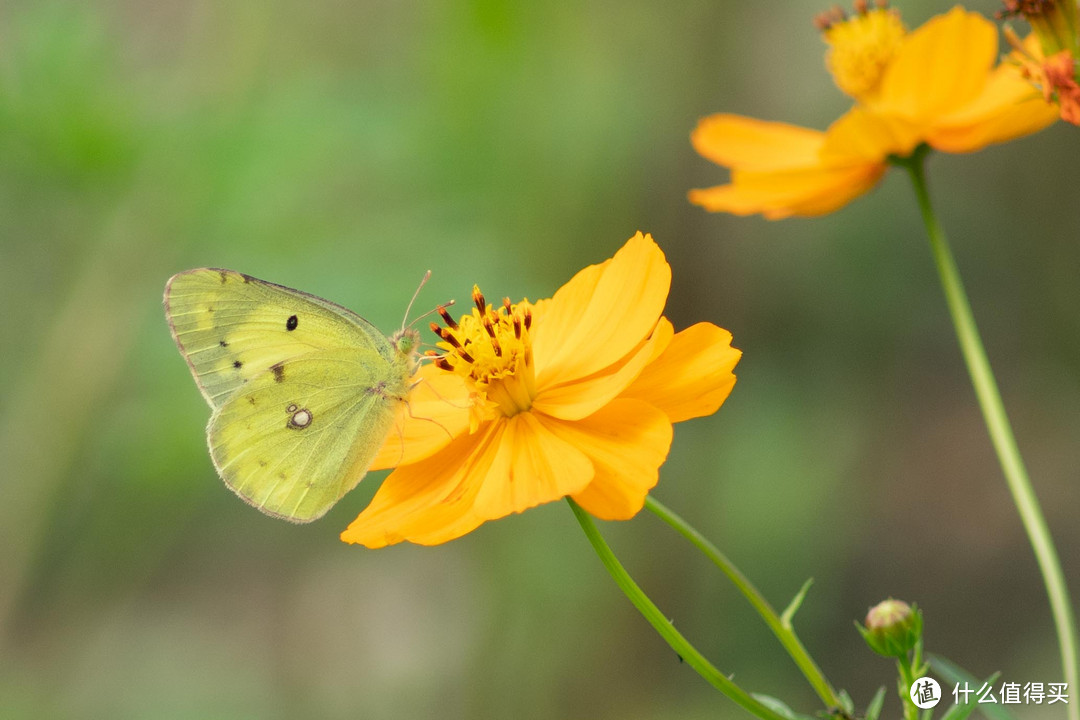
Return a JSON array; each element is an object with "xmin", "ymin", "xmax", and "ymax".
[{"xmin": 341, "ymin": 423, "xmax": 502, "ymax": 548}]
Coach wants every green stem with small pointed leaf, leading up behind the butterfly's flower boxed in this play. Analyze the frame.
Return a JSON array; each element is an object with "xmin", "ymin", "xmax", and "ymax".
[{"xmin": 645, "ymin": 495, "xmax": 840, "ymax": 708}]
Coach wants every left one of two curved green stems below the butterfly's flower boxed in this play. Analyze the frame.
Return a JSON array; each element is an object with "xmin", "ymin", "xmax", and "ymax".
[{"xmin": 566, "ymin": 498, "xmax": 784, "ymax": 720}]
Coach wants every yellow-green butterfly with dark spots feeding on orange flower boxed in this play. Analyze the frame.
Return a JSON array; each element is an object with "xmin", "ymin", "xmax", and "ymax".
[{"xmin": 165, "ymin": 268, "xmax": 422, "ymax": 522}]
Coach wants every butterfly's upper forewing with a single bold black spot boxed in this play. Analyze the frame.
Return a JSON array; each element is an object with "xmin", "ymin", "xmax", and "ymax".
[{"xmin": 165, "ymin": 268, "xmax": 395, "ymax": 409}]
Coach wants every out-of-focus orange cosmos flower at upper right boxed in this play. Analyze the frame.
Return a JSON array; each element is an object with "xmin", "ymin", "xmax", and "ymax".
[{"xmin": 690, "ymin": 2, "xmax": 1057, "ymax": 219}]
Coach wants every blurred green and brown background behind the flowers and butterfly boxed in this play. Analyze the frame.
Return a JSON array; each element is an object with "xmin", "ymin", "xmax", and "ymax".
[{"xmin": 0, "ymin": 0, "xmax": 1080, "ymax": 720}]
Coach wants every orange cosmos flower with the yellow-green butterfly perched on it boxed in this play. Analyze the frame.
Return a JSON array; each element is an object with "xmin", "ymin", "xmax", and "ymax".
[{"xmin": 341, "ymin": 233, "xmax": 741, "ymax": 547}]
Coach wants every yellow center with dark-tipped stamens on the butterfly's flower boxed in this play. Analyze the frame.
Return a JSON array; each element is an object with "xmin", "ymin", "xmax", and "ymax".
[{"xmin": 431, "ymin": 286, "xmax": 536, "ymax": 424}]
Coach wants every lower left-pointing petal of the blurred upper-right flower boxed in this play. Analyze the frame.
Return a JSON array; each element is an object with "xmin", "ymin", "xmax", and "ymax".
[{"xmin": 689, "ymin": 162, "xmax": 888, "ymax": 220}]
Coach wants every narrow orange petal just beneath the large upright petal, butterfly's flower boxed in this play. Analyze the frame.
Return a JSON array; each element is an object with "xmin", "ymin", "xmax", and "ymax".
[{"xmin": 532, "ymin": 317, "xmax": 674, "ymax": 420}]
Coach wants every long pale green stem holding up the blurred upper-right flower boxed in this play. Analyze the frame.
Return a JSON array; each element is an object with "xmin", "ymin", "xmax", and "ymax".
[{"xmin": 896, "ymin": 147, "xmax": 1080, "ymax": 720}]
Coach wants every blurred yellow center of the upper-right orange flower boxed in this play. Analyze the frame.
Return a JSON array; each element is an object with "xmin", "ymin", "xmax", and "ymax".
[{"xmin": 816, "ymin": 0, "xmax": 906, "ymax": 99}]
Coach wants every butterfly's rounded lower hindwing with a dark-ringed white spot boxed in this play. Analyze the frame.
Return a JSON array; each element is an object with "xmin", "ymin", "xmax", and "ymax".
[{"xmin": 206, "ymin": 349, "xmax": 408, "ymax": 522}]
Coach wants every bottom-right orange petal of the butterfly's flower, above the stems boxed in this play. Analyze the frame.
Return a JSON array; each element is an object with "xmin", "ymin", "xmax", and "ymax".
[{"xmin": 550, "ymin": 399, "xmax": 672, "ymax": 520}]
